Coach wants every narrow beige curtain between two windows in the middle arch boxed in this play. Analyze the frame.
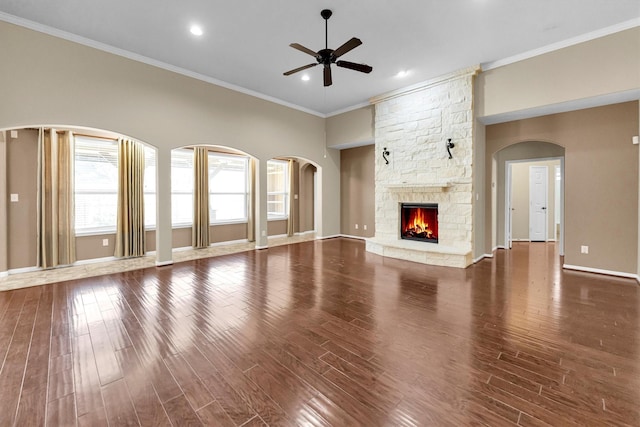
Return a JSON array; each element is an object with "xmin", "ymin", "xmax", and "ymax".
[{"xmin": 191, "ymin": 147, "xmax": 210, "ymax": 248}]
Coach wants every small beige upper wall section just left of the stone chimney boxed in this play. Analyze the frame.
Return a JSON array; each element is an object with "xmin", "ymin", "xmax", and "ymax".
[{"xmin": 326, "ymin": 105, "xmax": 375, "ymax": 148}]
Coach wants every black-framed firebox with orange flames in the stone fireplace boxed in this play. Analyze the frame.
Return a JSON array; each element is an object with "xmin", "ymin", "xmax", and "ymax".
[{"xmin": 400, "ymin": 203, "xmax": 438, "ymax": 243}]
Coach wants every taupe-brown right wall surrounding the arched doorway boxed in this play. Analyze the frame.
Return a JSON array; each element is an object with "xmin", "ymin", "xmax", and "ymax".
[{"xmin": 485, "ymin": 102, "xmax": 639, "ymax": 274}]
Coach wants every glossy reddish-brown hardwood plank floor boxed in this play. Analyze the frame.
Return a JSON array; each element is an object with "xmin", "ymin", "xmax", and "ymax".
[{"xmin": 0, "ymin": 239, "xmax": 640, "ymax": 427}]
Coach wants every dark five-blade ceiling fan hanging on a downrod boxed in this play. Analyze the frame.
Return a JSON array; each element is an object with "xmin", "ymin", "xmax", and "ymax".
[{"xmin": 284, "ymin": 9, "xmax": 373, "ymax": 86}]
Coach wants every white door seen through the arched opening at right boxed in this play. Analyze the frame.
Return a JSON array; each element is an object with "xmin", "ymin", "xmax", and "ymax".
[{"xmin": 529, "ymin": 166, "xmax": 549, "ymax": 242}]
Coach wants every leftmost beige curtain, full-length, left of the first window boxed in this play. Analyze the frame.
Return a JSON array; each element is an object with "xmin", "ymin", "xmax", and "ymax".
[{"xmin": 37, "ymin": 128, "xmax": 76, "ymax": 268}]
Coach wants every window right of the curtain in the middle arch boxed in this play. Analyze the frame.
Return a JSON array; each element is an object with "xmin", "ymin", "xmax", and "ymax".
[{"xmin": 209, "ymin": 152, "xmax": 249, "ymax": 224}]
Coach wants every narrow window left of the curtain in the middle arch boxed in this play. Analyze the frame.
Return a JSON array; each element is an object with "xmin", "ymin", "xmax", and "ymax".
[{"xmin": 171, "ymin": 149, "xmax": 193, "ymax": 226}]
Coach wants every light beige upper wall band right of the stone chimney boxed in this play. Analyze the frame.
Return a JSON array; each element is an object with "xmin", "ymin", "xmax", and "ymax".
[{"xmin": 476, "ymin": 27, "xmax": 640, "ymax": 117}]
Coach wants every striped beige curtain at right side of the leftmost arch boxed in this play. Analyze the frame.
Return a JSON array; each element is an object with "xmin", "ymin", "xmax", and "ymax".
[{"xmin": 115, "ymin": 138, "xmax": 145, "ymax": 258}]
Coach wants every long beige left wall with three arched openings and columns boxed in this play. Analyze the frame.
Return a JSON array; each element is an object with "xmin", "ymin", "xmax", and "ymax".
[{"xmin": 0, "ymin": 22, "xmax": 340, "ymax": 263}]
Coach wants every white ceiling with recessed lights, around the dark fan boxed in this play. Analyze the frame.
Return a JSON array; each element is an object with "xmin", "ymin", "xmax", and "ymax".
[{"xmin": 0, "ymin": 0, "xmax": 640, "ymax": 116}]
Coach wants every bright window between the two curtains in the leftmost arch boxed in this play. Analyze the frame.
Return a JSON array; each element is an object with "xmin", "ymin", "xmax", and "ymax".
[{"xmin": 75, "ymin": 136, "xmax": 118, "ymax": 234}]
